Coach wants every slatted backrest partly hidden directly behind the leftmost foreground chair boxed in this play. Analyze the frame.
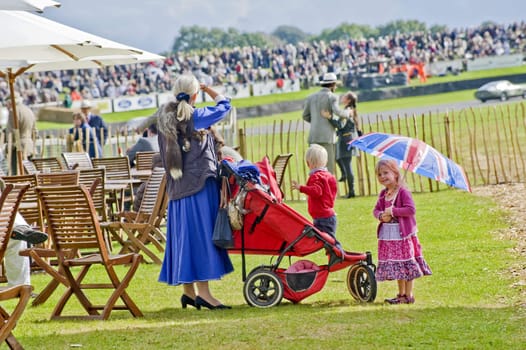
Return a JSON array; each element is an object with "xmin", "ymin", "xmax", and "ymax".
[{"xmin": 2, "ymin": 174, "xmax": 44, "ymax": 230}]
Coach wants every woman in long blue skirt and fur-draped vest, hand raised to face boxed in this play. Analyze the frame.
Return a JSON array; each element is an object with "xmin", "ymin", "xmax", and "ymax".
[{"xmin": 156, "ymin": 75, "xmax": 233, "ymax": 309}]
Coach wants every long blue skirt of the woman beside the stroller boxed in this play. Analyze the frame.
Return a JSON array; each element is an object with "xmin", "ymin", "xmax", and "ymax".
[{"xmin": 159, "ymin": 178, "xmax": 234, "ymax": 286}]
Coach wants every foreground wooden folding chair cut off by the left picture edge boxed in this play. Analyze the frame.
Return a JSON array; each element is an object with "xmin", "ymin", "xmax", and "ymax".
[{"xmin": 0, "ymin": 184, "xmax": 33, "ymax": 349}]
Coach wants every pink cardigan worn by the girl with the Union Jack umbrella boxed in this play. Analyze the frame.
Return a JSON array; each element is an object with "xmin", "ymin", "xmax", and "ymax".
[{"xmin": 373, "ymin": 187, "xmax": 418, "ymax": 237}]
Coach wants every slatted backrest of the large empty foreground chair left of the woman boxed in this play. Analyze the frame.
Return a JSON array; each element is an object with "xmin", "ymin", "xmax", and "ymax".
[{"xmin": 36, "ymin": 185, "xmax": 108, "ymax": 263}]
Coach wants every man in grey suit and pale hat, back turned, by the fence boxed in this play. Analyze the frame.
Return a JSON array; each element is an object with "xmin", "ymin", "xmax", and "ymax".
[{"xmin": 303, "ymin": 73, "xmax": 349, "ymax": 174}]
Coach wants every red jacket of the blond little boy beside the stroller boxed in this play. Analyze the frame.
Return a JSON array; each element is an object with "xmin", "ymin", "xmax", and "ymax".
[{"xmin": 300, "ymin": 169, "xmax": 338, "ymax": 219}]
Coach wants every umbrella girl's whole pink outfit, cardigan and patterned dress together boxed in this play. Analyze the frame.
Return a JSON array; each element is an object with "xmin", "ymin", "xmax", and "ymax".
[{"xmin": 373, "ymin": 188, "xmax": 431, "ymax": 281}]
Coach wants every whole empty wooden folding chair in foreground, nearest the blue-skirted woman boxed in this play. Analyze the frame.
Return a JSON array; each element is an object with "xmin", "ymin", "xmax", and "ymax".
[{"xmin": 37, "ymin": 185, "xmax": 142, "ymax": 320}]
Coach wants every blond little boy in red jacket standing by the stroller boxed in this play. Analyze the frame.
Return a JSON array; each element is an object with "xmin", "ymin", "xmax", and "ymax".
[{"xmin": 292, "ymin": 144, "xmax": 337, "ymax": 237}]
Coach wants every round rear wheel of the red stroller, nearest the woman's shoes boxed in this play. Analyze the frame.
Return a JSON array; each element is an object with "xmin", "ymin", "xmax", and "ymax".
[{"xmin": 243, "ymin": 269, "xmax": 283, "ymax": 308}]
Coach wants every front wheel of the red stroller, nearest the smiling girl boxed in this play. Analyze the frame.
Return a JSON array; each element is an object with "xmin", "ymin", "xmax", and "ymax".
[{"xmin": 347, "ymin": 264, "xmax": 377, "ymax": 302}]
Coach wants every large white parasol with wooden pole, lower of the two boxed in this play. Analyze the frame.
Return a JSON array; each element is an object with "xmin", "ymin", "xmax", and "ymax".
[{"xmin": 0, "ymin": 10, "xmax": 164, "ymax": 172}]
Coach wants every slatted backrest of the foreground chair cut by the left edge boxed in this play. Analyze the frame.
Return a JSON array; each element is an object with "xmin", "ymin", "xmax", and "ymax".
[{"xmin": 0, "ymin": 184, "xmax": 29, "ymax": 261}]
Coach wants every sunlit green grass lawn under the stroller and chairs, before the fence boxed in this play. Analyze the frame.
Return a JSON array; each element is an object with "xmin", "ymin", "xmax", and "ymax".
[{"xmin": 10, "ymin": 190, "xmax": 526, "ymax": 350}]
